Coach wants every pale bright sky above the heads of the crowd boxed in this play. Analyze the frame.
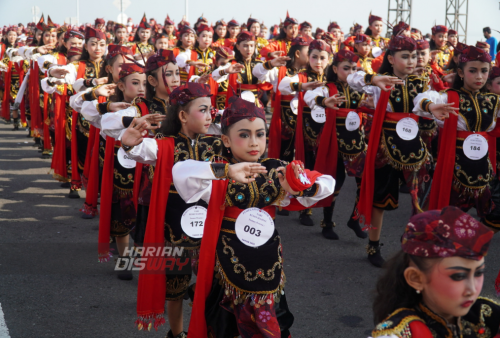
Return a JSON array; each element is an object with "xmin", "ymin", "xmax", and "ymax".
[{"xmin": 0, "ymin": 0, "xmax": 500, "ymax": 44}]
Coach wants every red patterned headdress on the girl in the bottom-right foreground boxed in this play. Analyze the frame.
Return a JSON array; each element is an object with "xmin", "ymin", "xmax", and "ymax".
[{"xmin": 401, "ymin": 206, "xmax": 493, "ymax": 261}]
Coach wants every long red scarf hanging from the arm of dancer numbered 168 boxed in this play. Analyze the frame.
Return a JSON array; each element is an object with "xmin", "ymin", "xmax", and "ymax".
[{"xmin": 357, "ymin": 91, "xmax": 391, "ymax": 227}]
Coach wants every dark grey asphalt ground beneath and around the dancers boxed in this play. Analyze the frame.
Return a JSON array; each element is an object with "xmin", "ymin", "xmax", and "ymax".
[{"xmin": 0, "ymin": 122, "xmax": 500, "ymax": 338}]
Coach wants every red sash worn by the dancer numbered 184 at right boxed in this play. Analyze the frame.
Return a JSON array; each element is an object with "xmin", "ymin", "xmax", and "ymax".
[{"xmin": 429, "ymin": 90, "xmax": 496, "ymax": 210}]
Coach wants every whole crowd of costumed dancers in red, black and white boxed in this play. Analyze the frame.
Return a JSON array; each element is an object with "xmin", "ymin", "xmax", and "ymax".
[{"xmin": 0, "ymin": 9, "xmax": 500, "ymax": 338}]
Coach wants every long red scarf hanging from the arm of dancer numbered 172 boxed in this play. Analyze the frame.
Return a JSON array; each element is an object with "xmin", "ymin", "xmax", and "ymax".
[{"xmin": 135, "ymin": 137, "xmax": 175, "ymax": 330}]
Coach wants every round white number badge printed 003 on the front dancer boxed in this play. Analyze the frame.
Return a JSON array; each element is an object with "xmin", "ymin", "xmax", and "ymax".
[{"xmin": 234, "ymin": 208, "xmax": 274, "ymax": 248}]
